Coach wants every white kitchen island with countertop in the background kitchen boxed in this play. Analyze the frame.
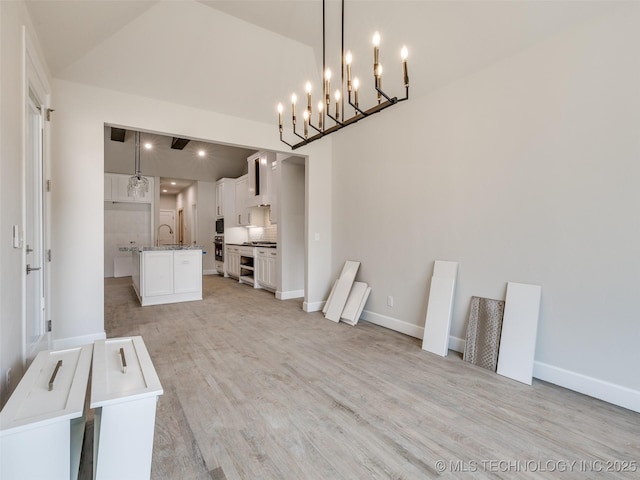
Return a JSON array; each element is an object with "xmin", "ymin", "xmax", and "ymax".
[{"xmin": 131, "ymin": 245, "xmax": 202, "ymax": 307}]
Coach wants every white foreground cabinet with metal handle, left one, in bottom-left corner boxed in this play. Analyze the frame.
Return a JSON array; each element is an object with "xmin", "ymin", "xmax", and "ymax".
[{"xmin": 0, "ymin": 345, "xmax": 93, "ymax": 480}]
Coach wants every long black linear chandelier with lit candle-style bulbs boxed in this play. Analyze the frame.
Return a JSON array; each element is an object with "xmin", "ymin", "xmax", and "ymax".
[{"xmin": 278, "ymin": 0, "xmax": 409, "ymax": 150}]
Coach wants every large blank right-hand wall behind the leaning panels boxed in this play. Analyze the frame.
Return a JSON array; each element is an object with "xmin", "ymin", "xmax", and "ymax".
[{"xmin": 332, "ymin": 5, "xmax": 640, "ymax": 410}]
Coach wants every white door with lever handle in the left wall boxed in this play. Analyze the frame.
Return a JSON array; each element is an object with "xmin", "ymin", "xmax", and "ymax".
[{"xmin": 23, "ymin": 92, "xmax": 45, "ymax": 358}]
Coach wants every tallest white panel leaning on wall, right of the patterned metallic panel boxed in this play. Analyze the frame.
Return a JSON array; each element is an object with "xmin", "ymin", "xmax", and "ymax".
[{"xmin": 497, "ymin": 282, "xmax": 542, "ymax": 385}]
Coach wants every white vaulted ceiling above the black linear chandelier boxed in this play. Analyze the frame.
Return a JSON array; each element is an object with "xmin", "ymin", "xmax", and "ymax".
[{"xmin": 27, "ymin": 0, "xmax": 622, "ymax": 123}]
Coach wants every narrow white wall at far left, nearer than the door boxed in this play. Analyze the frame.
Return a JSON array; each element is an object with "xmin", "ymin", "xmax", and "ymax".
[{"xmin": 0, "ymin": 2, "xmax": 49, "ymax": 407}]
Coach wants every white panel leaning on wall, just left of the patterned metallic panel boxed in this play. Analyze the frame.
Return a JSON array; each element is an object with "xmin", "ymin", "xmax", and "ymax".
[{"xmin": 422, "ymin": 260, "xmax": 458, "ymax": 357}]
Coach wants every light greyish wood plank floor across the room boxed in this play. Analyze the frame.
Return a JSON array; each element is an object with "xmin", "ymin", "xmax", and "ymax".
[{"xmin": 83, "ymin": 276, "xmax": 640, "ymax": 480}]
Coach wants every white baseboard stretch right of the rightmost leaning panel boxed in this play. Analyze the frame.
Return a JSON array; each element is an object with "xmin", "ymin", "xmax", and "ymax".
[{"xmin": 533, "ymin": 362, "xmax": 640, "ymax": 413}]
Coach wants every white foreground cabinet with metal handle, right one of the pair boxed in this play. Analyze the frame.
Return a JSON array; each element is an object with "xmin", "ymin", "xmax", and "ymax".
[{"xmin": 92, "ymin": 336, "xmax": 164, "ymax": 480}]
